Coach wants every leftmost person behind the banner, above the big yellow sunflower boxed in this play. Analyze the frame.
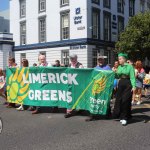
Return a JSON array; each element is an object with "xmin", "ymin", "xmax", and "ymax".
[{"xmin": 6, "ymin": 57, "xmax": 17, "ymax": 108}]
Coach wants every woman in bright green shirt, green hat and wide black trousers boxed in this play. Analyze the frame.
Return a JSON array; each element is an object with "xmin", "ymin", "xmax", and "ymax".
[{"xmin": 113, "ymin": 53, "xmax": 136, "ymax": 126}]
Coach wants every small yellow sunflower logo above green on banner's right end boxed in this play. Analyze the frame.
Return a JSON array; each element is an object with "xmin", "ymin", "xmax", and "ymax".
[{"xmin": 92, "ymin": 76, "xmax": 107, "ymax": 96}]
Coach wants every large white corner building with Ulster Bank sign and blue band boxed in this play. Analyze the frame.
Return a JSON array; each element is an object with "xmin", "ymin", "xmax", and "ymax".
[{"xmin": 10, "ymin": 0, "xmax": 150, "ymax": 67}]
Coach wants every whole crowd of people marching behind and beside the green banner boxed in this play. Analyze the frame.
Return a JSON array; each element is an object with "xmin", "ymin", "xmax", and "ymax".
[{"xmin": 0, "ymin": 53, "xmax": 150, "ymax": 126}]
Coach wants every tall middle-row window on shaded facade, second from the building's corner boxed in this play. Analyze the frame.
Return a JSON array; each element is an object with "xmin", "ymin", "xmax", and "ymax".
[{"xmin": 104, "ymin": 12, "xmax": 111, "ymax": 41}]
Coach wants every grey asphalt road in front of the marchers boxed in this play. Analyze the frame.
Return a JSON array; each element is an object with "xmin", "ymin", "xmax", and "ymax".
[{"xmin": 0, "ymin": 96, "xmax": 150, "ymax": 150}]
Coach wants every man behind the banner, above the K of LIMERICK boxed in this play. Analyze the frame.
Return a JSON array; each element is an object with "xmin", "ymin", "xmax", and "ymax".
[{"xmin": 64, "ymin": 54, "xmax": 84, "ymax": 118}]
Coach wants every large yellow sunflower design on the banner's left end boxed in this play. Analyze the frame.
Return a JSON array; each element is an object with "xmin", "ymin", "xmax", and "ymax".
[{"xmin": 7, "ymin": 68, "xmax": 29, "ymax": 104}]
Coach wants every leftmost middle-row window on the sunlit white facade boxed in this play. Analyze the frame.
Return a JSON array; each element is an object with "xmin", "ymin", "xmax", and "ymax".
[{"xmin": 20, "ymin": 22, "xmax": 26, "ymax": 45}]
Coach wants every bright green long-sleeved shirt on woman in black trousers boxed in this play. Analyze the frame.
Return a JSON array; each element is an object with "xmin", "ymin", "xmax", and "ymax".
[{"xmin": 116, "ymin": 63, "xmax": 136, "ymax": 88}]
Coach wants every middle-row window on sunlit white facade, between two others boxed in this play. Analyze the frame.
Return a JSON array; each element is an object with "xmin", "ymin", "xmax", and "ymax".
[{"xmin": 39, "ymin": 17, "xmax": 46, "ymax": 43}]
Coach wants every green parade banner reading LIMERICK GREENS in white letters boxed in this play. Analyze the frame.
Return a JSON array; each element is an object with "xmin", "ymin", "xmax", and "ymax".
[{"xmin": 7, "ymin": 67, "xmax": 114, "ymax": 115}]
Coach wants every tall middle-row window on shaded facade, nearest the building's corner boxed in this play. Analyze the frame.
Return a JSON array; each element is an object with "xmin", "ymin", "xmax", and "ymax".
[{"xmin": 91, "ymin": 9, "xmax": 100, "ymax": 39}]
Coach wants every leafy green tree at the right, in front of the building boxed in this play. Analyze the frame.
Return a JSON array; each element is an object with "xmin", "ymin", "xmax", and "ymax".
[{"xmin": 115, "ymin": 12, "xmax": 150, "ymax": 60}]
